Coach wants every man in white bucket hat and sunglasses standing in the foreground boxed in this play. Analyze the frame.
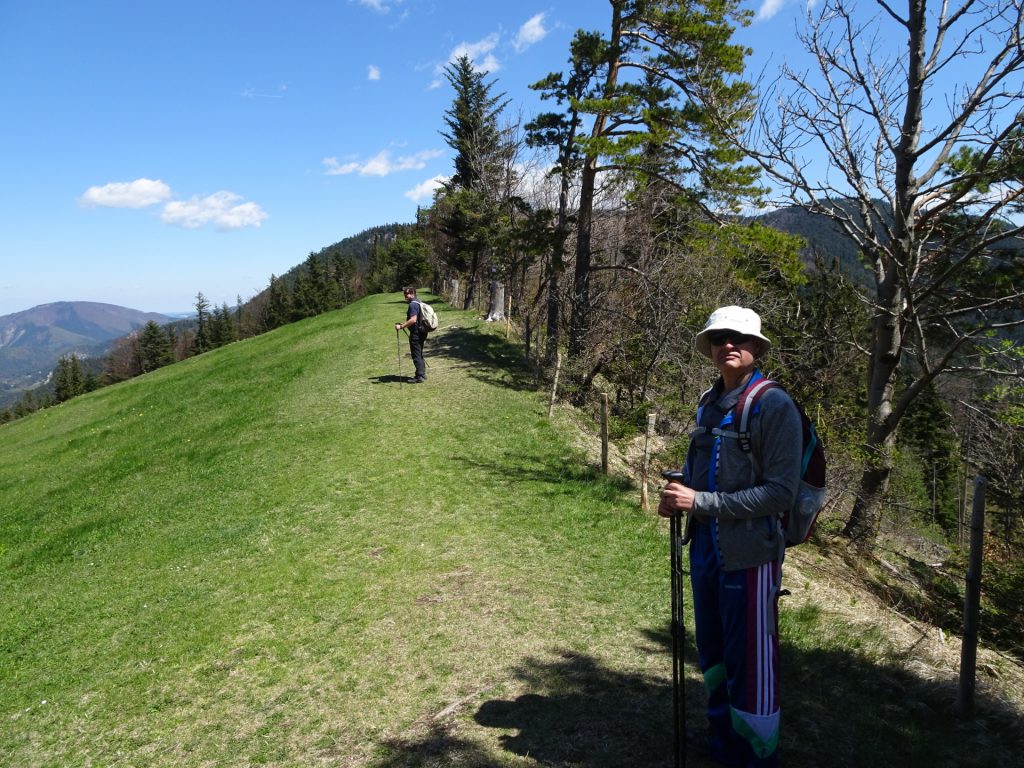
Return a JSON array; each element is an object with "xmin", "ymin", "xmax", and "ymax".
[{"xmin": 657, "ymin": 306, "xmax": 803, "ymax": 768}]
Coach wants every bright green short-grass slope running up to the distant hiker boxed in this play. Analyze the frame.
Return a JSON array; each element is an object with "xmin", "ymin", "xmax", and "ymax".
[{"xmin": 0, "ymin": 295, "xmax": 1021, "ymax": 768}]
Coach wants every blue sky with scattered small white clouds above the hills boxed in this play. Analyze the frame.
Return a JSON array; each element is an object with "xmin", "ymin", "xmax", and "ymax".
[{"xmin": 0, "ymin": 0, "xmax": 798, "ymax": 315}]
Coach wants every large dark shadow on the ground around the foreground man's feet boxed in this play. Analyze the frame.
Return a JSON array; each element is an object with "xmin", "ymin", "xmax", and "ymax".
[{"xmin": 372, "ymin": 628, "xmax": 1024, "ymax": 768}]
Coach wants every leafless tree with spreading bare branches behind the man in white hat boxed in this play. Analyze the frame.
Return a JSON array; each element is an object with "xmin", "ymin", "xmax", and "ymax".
[{"xmin": 737, "ymin": 0, "xmax": 1024, "ymax": 544}]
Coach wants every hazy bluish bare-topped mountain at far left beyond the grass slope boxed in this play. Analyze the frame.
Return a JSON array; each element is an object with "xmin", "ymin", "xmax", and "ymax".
[{"xmin": 0, "ymin": 301, "xmax": 171, "ymax": 404}]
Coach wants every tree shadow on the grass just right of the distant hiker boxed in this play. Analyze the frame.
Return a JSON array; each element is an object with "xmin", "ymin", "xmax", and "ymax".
[{"xmin": 424, "ymin": 326, "xmax": 537, "ymax": 390}]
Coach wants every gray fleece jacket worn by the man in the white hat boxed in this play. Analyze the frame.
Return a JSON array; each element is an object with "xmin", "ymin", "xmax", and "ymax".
[{"xmin": 685, "ymin": 374, "xmax": 803, "ymax": 570}]
